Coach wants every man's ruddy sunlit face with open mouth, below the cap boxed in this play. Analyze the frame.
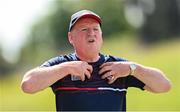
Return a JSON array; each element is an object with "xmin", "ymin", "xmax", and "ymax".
[{"xmin": 68, "ymin": 18, "xmax": 103, "ymax": 55}]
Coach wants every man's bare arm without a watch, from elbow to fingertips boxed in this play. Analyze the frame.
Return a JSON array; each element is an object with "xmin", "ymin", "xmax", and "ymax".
[{"xmin": 21, "ymin": 61, "xmax": 92, "ymax": 93}]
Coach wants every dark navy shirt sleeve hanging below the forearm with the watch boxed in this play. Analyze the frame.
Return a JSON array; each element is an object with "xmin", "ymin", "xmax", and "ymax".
[{"xmin": 126, "ymin": 76, "xmax": 145, "ymax": 90}]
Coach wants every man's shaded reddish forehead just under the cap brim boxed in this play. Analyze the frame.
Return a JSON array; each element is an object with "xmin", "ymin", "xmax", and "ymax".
[{"xmin": 74, "ymin": 18, "xmax": 99, "ymax": 27}]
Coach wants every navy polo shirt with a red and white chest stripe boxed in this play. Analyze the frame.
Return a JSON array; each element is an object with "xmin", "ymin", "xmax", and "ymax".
[{"xmin": 41, "ymin": 53, "xmax": 145, "ymax": 111}]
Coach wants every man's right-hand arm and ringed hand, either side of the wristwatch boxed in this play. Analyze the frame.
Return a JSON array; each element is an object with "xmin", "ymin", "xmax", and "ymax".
[{"xmin": 99, "ymin": 62, "xmax": 171, "ymax": 93}]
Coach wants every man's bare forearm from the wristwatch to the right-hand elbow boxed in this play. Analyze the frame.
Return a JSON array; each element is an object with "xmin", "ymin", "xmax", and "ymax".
[{"xmin": 133, "ymin": 64, "xmax": 171, "ymax": 93}]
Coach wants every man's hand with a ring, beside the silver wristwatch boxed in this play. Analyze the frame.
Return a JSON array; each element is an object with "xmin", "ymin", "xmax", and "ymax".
[{"xmin": 99, "ymin": 62, "xmax": 131, "ymax": 84}]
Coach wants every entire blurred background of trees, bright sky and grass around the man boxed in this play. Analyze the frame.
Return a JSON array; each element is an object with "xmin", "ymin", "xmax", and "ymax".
[{"xmin": 0, "ymin": 0, "xmax": 180, "ymax": 111}]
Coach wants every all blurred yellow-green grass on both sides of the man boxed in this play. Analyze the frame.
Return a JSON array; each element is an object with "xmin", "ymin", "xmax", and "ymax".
[{"xmin": 0, "ymin": 35, "xmax": 180, "ymax": 111}]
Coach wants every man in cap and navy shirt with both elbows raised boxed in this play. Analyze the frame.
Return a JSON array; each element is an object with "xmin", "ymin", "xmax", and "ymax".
[{"xmin": 22, "ymin": 10, "xmax": 171, "ymax": 111}]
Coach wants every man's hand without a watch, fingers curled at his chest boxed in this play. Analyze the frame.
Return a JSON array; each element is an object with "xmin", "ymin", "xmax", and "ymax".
[{"xmin": 62, "ymin": 61, "xmax": 93, "ymax": 81}]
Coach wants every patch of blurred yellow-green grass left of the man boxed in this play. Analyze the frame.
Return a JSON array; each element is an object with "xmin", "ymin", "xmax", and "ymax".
[{"xmin": 0, "ymin": 75, "xmax": 55, "ymax": 111}]
